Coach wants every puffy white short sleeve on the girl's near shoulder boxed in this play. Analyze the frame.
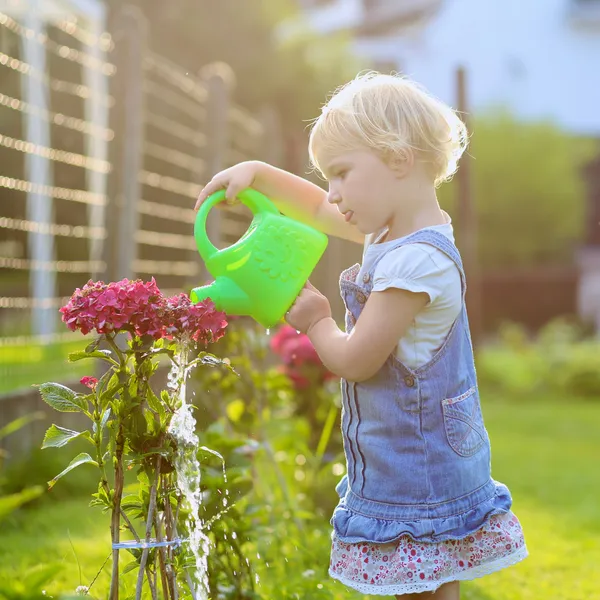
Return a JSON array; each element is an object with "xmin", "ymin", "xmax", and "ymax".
[{"xmin": 373, "ymin": 243, "xmax": 461, "ymax": 303}]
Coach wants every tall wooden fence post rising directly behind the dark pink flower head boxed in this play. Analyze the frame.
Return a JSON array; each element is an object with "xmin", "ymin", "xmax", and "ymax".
[{"xmin": 104, "ymin": 5, "xmax": 148, "ymax": 281}]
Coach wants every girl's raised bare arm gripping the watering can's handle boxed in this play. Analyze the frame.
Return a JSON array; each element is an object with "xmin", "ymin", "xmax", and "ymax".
[{"xmin": 196, "ymin": 161, "xmax": 364, "ymax": 244}]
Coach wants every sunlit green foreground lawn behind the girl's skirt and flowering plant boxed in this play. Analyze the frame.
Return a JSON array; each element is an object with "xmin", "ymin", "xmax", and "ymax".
[{"xmin": 0, "ymin": 393, "xmax": 600, "ymax": 600}]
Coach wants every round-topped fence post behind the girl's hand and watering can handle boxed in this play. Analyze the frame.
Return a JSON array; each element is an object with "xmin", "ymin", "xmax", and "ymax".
[{"xmin": 199, "ymin": 62, "xmax": 235, "ymax": 253}]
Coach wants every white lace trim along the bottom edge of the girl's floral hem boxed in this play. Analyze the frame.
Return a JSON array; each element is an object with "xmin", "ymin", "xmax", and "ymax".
[{"xmin": 329, "ymin": 546, "xmax": 529, "ymax": 596}]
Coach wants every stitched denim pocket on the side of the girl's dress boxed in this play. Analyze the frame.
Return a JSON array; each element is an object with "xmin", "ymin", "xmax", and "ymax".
[{"xmin": 442, "ymin": 386, "xmax": 488, "ymax": 457}]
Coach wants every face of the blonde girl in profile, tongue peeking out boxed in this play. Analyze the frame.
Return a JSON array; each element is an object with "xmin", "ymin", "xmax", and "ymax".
[{"xmin": 324, "ymin": 150, "xmax": 404, "ymax": 235}]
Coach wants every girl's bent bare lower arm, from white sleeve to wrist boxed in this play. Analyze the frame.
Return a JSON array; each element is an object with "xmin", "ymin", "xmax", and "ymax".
[{"xmin": 308, "ymin": 288, "xmax": 429, "ymax": 381}]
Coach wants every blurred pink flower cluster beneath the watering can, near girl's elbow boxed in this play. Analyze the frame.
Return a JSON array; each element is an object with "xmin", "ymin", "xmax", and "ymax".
[{"xmin": 271, "ymin": 325, "xmax": 335, "ymax": 390}]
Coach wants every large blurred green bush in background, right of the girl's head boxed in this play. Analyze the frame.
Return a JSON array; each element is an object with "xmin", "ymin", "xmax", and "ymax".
[{"xmin": 440, "ymin": 113, "xmax": 594, "ymax": 268}]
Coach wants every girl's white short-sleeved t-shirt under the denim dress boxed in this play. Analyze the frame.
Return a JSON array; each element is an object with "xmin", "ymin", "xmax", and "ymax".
[{"xmin": 357, "ymin": 215, "xmax": 462, "ymax": 369}]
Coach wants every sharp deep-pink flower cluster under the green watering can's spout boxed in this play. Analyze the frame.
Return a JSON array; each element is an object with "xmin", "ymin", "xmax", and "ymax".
[{"xmin": 60, "ymin": 278, "xmax": 227, "ymax": 344}]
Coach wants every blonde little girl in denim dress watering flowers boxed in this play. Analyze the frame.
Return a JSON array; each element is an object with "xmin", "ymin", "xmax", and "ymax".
[{"xmin": 196, "ymin": 73, "xmax": 527, "ymax": 600}]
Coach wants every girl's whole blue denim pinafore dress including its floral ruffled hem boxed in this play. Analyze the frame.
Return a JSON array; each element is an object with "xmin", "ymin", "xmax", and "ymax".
[{"xmin": 329, "ymin": 229, "xmax": 527, "ymax": 594}]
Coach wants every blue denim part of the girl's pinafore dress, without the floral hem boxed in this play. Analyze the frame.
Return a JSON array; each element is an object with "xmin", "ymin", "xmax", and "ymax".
[{"xmin": 332, "ymin": 229, "xmax": 511, "ymax": 543}]
